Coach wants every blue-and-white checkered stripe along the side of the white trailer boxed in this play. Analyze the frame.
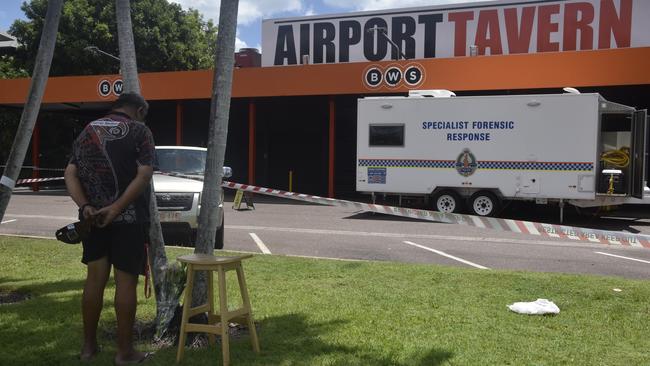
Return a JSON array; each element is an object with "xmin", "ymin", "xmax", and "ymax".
[{"xmin": 359, "ymin": 159, "xmax": 594, "ymax": 171}]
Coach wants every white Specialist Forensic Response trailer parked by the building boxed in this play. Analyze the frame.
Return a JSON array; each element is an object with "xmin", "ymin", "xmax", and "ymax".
[{"xmin": 356, "ymin": 92, "xmax": 650, "ymax": 220}]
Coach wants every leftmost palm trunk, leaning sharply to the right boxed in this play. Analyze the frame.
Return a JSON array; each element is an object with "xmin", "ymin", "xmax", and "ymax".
[{"xmin": 0, "ymin": 0, "xmax": 63, "ymax": 221}]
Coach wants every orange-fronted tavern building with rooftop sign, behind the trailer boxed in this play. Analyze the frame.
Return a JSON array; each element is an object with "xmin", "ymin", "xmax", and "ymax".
[{"xmin": 0, "ymin": 0, "xmax": 650, "ymax": 197}]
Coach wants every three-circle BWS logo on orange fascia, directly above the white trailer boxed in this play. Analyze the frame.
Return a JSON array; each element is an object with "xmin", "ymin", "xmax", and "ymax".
[{"xmin": 363, "ymin": 64, "xmax": 424, "ymax": 89}]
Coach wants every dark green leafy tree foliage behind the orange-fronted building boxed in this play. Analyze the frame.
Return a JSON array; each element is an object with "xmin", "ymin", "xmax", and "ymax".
[{"xmin": 9, "ymin": 0, "xmax": 217, "ymax": 76}]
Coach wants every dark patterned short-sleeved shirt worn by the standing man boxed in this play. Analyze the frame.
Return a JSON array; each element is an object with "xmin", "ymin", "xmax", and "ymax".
[{"xmin": 70, "ymin": 112, "xmax": 155, "ymax": 224}]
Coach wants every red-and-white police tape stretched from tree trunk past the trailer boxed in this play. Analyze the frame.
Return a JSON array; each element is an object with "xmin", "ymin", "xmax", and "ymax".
[{"xmin": 223, "ymin": 181, "xmax": 650, "ymax": 249}]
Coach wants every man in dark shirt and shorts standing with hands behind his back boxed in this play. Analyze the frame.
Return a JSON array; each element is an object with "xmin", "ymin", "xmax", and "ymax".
[{"xmin": 65, "ymin": 93, "xmax": 155, "ymax": 365}]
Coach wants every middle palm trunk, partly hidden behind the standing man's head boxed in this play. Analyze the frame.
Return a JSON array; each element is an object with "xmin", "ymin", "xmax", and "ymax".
[{"xmin": 115, "ymin": 0, "xmax": 185, "ymax": 339}]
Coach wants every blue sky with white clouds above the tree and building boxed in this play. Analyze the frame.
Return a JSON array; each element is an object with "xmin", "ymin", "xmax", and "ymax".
[{"xmin": 0, "ymin": 0, "xmax": 479, "ymax": 49}]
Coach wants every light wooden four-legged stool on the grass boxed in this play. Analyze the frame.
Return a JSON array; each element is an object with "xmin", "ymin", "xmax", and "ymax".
[{"xmin": 176, "ymin": 254, "xmax": 260, "ymax": 366}]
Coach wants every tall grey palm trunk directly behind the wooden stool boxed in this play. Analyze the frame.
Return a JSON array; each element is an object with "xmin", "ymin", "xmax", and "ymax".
[{"xmin": 192, "ymin": 0, "xmax": 239, "ymax": 304}]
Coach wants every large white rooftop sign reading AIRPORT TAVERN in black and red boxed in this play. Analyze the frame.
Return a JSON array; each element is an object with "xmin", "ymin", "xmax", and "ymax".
[{"xmin": 262, "ymin": 0, "xmax": 650, "ymax": 66}]
